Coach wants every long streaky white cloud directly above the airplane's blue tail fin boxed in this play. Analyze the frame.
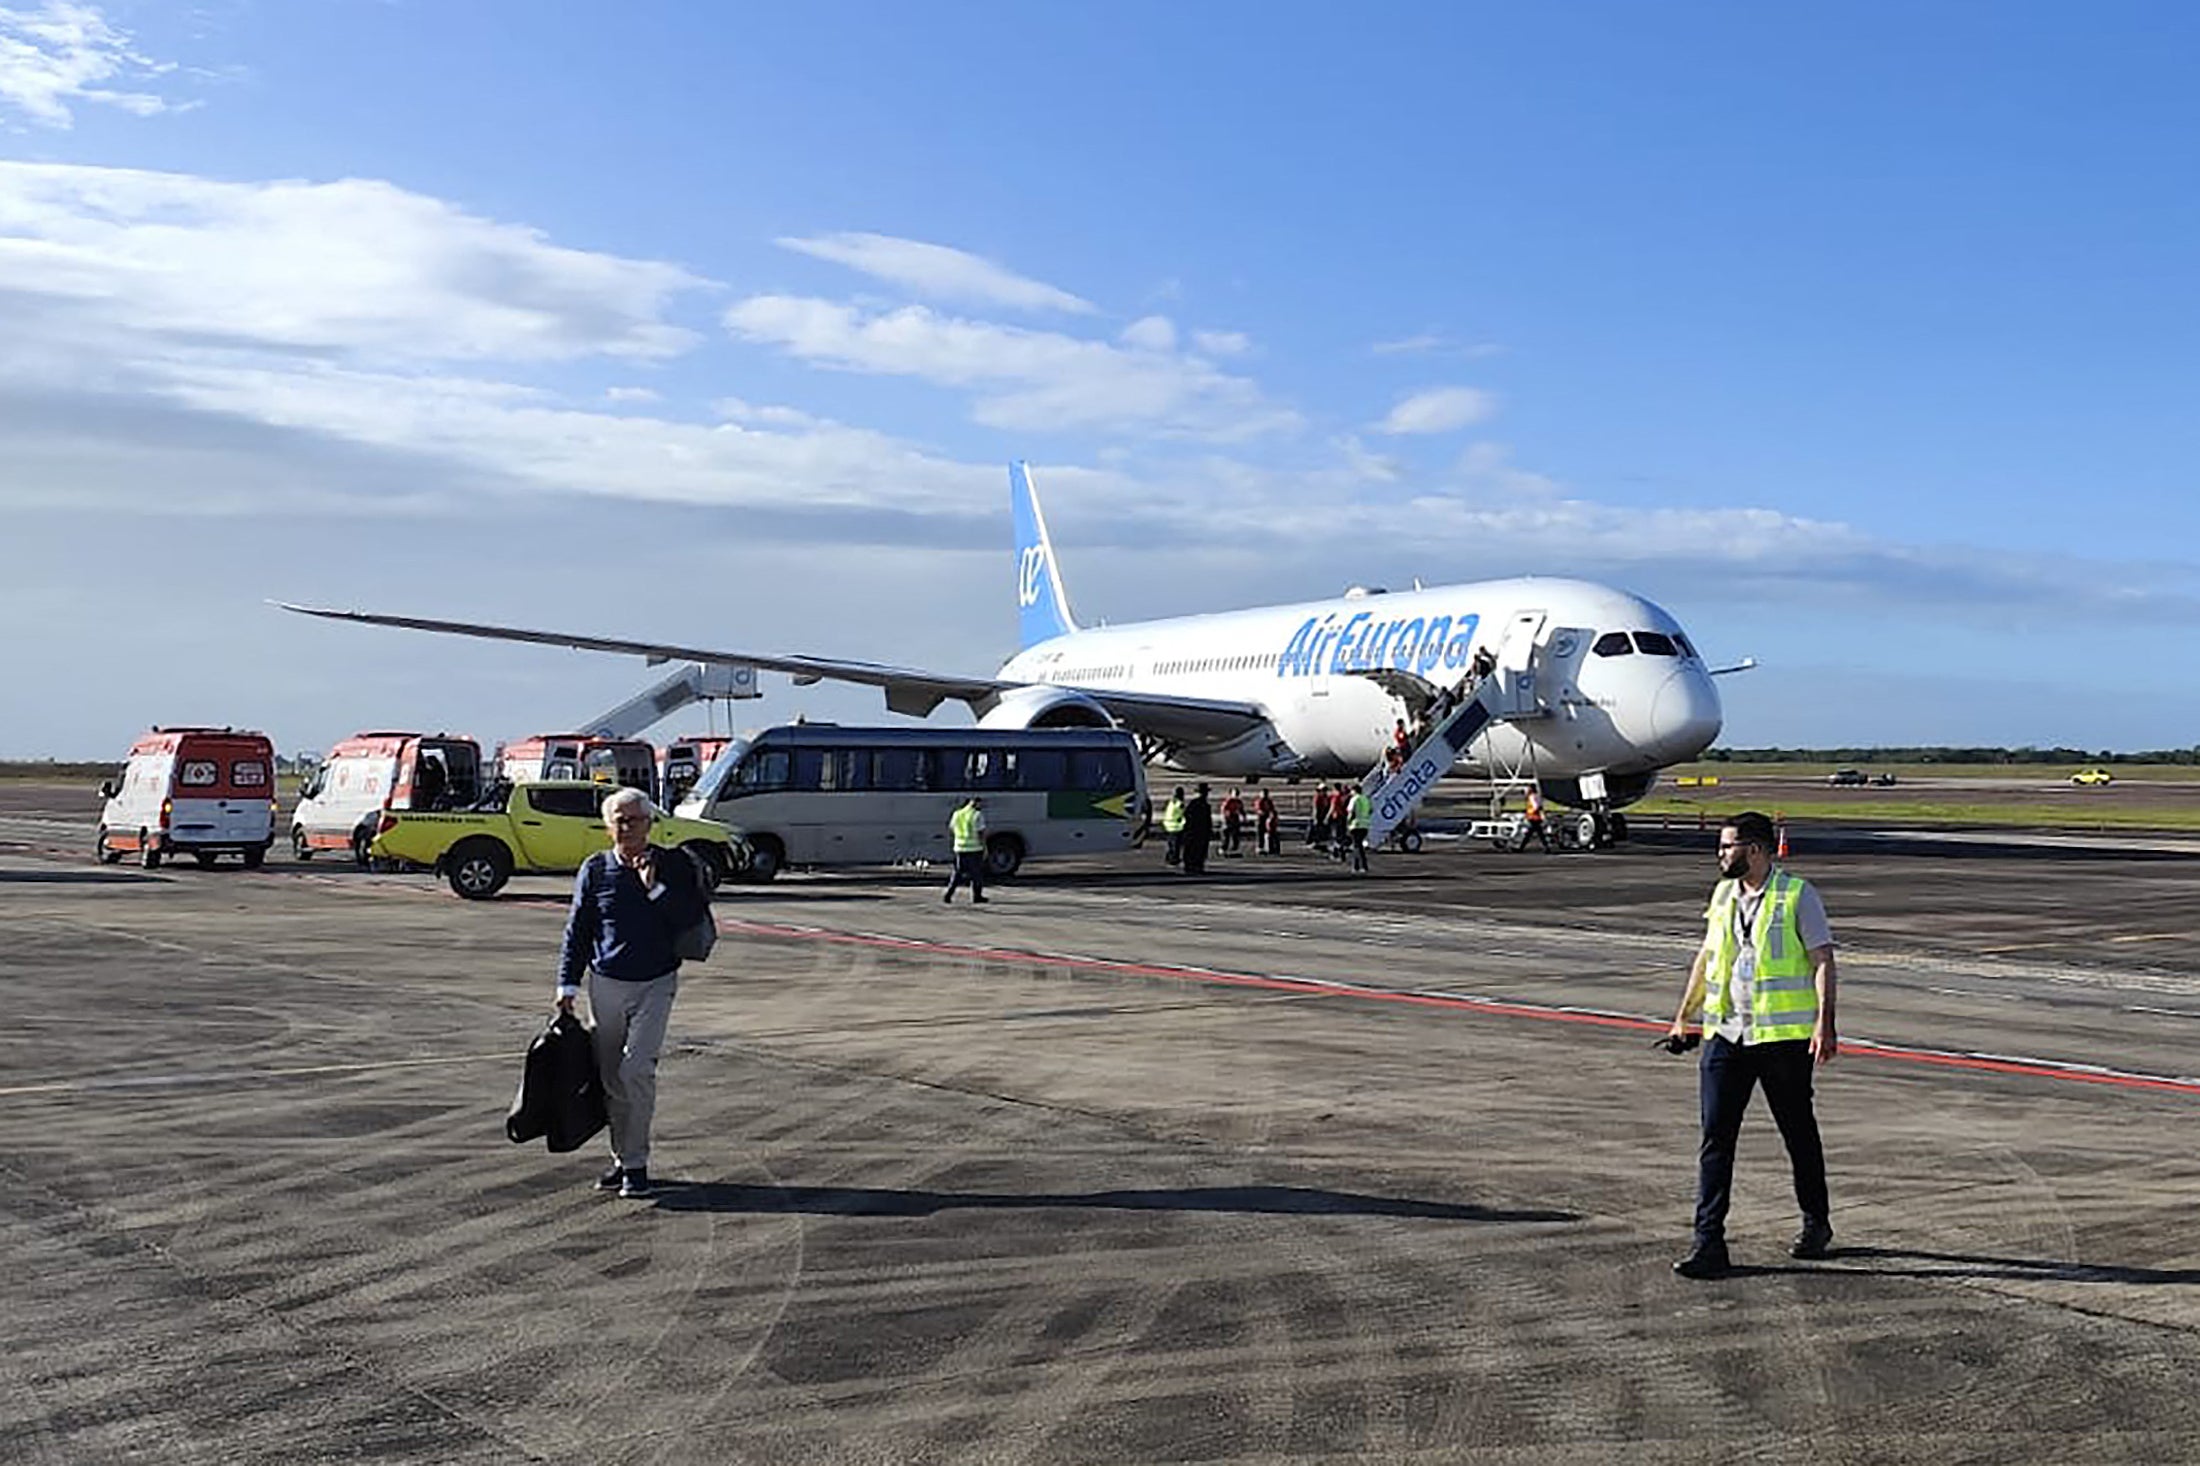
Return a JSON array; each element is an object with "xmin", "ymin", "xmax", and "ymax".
[{"xmin": 726, "ymin": 295, "xmax": 1298, "ymax": 442}]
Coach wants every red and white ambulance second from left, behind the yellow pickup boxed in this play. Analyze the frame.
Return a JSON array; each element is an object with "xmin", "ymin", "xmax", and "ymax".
[{"xmin": 290, "ymin": 731, "xmax": 482, "ymax": 865}]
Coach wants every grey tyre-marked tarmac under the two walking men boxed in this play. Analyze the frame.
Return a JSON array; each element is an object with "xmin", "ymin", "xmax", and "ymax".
[{"xmin": 0, "ymin": 786, "xmax": 2200, "ymax": 1466}]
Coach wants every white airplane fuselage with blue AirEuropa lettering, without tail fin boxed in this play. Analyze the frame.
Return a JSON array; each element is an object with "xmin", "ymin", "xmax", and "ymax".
[{"xmin": 999, "ymin": 577, "xmax": 1720, "ymax": 788}]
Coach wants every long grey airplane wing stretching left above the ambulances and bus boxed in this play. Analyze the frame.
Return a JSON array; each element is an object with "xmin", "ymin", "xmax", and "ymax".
[{"xmin": 273, "ymin": 601, "xmax": 1267, "ymax": 744}]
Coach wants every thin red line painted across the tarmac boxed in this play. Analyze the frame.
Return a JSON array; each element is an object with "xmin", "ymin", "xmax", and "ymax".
[{"xmin": 719, "ymin": 918, "xmax": 2200, "ymax": 1098}]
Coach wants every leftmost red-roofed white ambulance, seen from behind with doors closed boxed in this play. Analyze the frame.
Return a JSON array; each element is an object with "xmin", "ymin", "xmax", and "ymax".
[{"xmin": 97, "ymin": 729, "xmax": 275, "ymax": 869}]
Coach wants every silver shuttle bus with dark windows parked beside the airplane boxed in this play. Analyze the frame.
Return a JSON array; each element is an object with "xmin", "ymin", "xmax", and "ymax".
[{"xmin": 678, "ymin": 722, "xmax": 1146, "ymax": 880}]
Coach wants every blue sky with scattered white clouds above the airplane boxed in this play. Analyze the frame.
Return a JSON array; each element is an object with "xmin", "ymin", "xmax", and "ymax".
[{"xmin": 0, "ymin": 0, "xmax": 2200, "ymax": 757}]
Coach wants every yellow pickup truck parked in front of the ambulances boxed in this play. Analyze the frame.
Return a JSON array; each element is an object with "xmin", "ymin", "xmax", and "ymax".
[{"xmin": 367, "ymin": 779, "xmax": 748, "ymax": 900}]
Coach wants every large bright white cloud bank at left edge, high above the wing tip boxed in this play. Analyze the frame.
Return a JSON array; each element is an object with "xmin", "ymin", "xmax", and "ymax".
[{"xmin": 0, "ymin": 161, "xmax": 706, "ymax": 361}]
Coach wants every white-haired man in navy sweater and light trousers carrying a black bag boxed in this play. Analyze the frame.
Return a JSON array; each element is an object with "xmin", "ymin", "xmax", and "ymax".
[{"xmin": 557, "ymin": 788, "xmax": 711, "ymax": 1197}]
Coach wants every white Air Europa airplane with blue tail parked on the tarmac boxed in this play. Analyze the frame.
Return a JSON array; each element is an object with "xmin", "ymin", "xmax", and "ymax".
[{"xmin": 277, "ymin": 462, "xmax": 1727, "ymax": 808}]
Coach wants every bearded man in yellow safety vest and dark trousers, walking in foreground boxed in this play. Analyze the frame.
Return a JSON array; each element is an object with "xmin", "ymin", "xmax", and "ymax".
[{"xmin": 1668, "ymin": 810, "xmax": 1839, "ymax": 1279}]
